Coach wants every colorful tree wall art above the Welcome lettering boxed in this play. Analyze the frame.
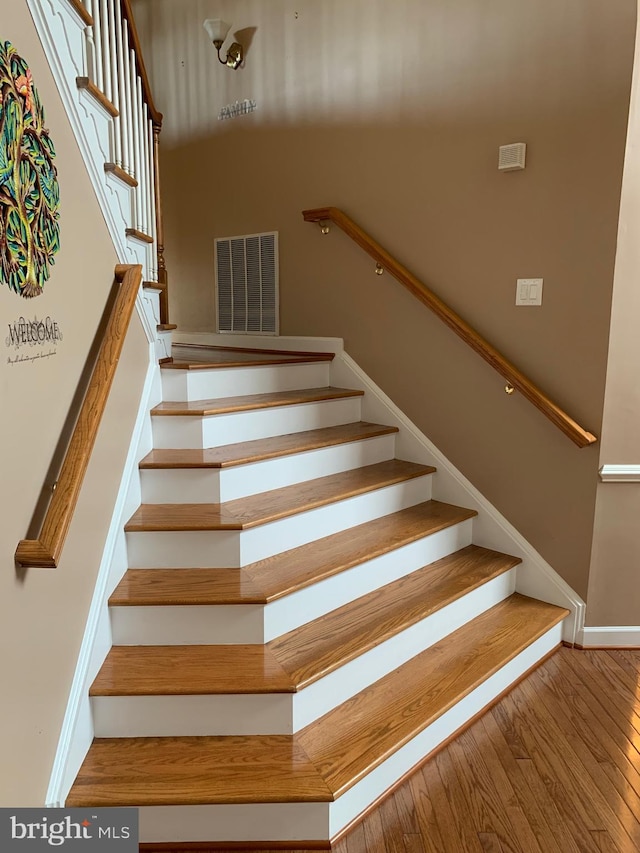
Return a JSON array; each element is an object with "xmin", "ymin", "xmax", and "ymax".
[{"xmin": 0, "ymin": 41, "xmax": 60, "ymax": 298}]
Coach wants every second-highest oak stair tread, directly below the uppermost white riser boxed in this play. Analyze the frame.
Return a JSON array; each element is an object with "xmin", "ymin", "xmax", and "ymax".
[{"xmin": 151, "ymin": 386, "xmax": 364, "ymax": 417}]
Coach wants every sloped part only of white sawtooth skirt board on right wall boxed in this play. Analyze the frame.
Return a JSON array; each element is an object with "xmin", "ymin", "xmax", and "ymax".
[{"xmin": 331, "ymin": 352, "xmax": 586, "ymax": 643}]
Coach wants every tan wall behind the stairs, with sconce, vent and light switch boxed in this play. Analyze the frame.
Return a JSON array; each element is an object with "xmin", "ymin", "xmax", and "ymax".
[{"xmin": 136, "ymin": 0, "xmax": 636, "ymax": 595}]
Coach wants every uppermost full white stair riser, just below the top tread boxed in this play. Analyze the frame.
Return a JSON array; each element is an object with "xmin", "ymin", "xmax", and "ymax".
[{"xmin": 162, "ymin": 355, "xmax": 330, "ymax": 403}]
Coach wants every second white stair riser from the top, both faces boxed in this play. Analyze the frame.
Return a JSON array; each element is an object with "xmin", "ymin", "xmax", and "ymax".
[{"xmin": 152, "ymin": 397, "xmax": 360, "ymax": 449}]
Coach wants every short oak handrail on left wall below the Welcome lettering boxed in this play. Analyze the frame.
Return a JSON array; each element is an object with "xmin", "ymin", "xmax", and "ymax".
[{"xmin": 15, "ymin": 264, "xmax": 142, "ymax": 568}]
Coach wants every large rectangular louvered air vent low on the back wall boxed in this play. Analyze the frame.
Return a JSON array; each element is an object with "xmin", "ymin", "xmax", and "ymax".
[{"xmin": 215, "ymin": 231, "xmax": 279, "ymax": 335}]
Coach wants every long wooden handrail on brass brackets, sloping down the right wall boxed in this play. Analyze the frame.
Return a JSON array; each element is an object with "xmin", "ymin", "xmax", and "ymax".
[{"xmin": 302, "ymin": 207, "xmax": 598, "ymax": 447}]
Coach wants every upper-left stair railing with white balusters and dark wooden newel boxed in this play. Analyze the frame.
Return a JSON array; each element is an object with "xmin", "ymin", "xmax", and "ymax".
[{"xmin": 69, "ymin": 0, "xmax": 169, "ymax": 324}]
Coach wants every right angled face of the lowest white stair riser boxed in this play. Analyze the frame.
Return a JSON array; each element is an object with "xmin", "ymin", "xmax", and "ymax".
[{"xmin": 331, "ymin": 625, "xmax": 562, "ymax": 838}]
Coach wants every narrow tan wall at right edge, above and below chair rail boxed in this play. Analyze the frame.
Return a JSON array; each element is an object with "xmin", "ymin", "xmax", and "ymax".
[{"xmin": 587, "ymin": 13, "xmax": 640, "ymax": 625}]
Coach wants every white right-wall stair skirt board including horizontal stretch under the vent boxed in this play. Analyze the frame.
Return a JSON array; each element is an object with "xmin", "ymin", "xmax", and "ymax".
[{"xmin": 174, "ymin": 332, "xmax": 586, "ymax": 645}]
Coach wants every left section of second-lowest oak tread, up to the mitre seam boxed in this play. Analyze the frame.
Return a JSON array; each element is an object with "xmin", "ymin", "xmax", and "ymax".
[{"xmin": 90, "ymin": 645, "xmax": 294, "ymax": 696}]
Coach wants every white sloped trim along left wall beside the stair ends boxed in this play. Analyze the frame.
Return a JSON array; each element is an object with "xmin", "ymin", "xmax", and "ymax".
[{"xmin": 45, "ymin": 352, "xmax": 159, "ymax": 808}]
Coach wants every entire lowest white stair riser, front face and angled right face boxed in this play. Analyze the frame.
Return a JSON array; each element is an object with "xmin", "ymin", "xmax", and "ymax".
[{"xmin": 132, "ymin": 624, "xmax": 562, "ymax": 846}]
